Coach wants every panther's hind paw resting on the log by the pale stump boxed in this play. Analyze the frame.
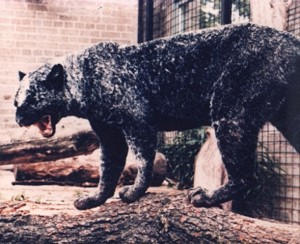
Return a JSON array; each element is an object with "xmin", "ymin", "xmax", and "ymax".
[{"xmin": 188, "ymin": 187, "xmax": 214, "ymax": 208}]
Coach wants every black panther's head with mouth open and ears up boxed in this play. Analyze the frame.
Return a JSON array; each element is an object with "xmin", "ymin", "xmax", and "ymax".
[{"xmin": 15, "ymin": 64, "xmax": 65, "ymax": 137}]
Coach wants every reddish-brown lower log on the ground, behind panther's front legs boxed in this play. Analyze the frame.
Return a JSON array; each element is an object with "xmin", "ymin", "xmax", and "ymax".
[{"xmin": 12, "ymin": 152, "xmax": 167, "ymax": 187}]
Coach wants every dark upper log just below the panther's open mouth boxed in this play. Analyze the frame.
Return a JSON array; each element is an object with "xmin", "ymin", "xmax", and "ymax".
[{"xmin": 0, "ymin": 131, "xmax": 99, "ymax": 165}]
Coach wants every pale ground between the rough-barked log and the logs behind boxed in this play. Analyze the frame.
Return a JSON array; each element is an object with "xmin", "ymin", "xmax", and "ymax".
[{"xmin": 0, "ymin": 166, "xmax": 175, "ymax": 215}]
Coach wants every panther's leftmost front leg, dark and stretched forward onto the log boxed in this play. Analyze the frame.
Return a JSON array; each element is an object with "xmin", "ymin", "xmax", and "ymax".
[{"xmin": 74, "ymin": 123, "xmax": 128, "ymax": 210}]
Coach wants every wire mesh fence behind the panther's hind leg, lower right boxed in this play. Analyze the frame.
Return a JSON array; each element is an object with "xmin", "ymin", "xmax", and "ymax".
[{"xmin": 258, "ymin": 123, "xmax": 300, "ymax": 224}]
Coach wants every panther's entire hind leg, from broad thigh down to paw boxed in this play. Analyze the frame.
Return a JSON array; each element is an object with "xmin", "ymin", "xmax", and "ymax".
[{"xmin": 189, "ymin": 58, "xmax": 286, "ymax": 207}]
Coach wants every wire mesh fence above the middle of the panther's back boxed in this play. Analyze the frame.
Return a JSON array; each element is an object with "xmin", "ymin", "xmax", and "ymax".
[{"xmin": 139, "ymin": 0, "xmax": 250, "ymax": 42}]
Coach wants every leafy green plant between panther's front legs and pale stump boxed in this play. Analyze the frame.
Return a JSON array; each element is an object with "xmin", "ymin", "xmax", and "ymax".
[{"xmin": 158, "ymin": 129, "xmax": 205, "ymax": 189}]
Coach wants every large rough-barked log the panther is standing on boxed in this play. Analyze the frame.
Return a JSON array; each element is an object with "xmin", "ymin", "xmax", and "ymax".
[{"xmin": 0, "ymin": 193, "xmax": 300, "ymax": 243}]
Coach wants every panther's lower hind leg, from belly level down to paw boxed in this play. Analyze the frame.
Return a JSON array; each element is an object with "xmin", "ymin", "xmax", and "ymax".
[{"xmin": 188, "ymin": 119, "xmax": 259, "ymax": 207}]
